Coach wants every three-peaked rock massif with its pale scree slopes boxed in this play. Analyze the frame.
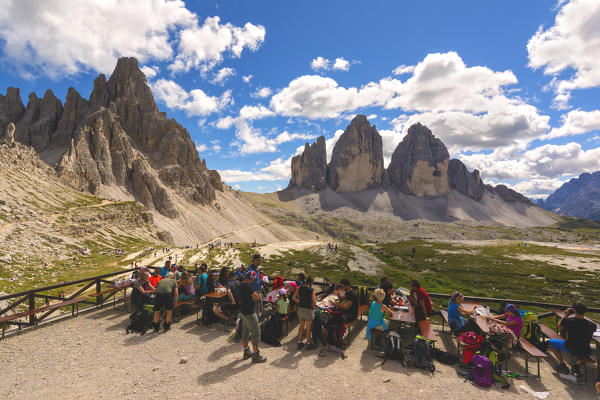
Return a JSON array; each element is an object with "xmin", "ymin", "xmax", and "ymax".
[{"xmin": 279, "ymin": 115, "xmax": 556, "ymax": 227}]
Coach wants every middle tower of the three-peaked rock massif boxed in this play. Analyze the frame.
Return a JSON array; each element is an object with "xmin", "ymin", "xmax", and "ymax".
[{"xmin": 327, "ymin": 115, "xmax": 384, "ymax": 192}]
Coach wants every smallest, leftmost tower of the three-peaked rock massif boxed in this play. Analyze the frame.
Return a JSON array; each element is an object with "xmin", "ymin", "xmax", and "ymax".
[{"xmin": 289, "ymin": 136, "xmax": 327, "ymax": 192}]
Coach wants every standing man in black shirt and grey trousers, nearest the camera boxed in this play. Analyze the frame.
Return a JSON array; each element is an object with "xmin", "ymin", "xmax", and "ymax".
[{"xmin": 239, "ymin": 271, "xmax": 267, "ymax": 363}]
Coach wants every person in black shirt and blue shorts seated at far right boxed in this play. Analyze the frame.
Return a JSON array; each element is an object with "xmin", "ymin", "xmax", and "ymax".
[{"xmin": 549, "ymin": 302, "xmax": 596, "ymax": 379}]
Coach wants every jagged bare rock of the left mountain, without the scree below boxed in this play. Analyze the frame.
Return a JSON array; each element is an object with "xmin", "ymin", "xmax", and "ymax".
[{"xmin": 0, "ymin": 58, "xmax": 223, "ymax": 217}]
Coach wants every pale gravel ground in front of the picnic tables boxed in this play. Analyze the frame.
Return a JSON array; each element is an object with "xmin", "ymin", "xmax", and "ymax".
[{"xmin": 0, "ymin": 309, "xmax": 597, "ymax": 400}]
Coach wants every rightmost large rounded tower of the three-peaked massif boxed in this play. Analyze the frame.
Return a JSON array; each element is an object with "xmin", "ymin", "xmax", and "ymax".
[{"xmin": 387, "ymin": 123, "xmax": 450, "ymax": 197}]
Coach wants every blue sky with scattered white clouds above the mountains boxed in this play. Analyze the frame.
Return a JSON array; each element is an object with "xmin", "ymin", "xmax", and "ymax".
[{"xmin": 0, "ymin": 0, "xmax": 600, "ymax": 197}]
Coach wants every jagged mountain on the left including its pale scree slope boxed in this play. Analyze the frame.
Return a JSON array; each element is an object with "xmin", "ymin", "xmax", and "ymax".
[{"xmin": 0, "ymin": 57, "xmax": 308, "ymax": 245}]
